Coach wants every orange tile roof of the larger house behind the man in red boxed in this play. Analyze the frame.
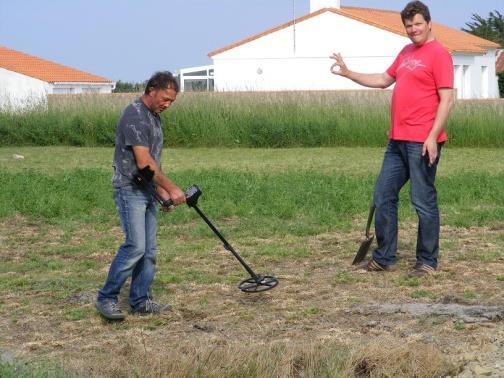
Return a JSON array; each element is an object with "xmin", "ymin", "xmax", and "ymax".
[{"xmin": 208, "ymin": 7, "xmax": 499, "ymax": 57}]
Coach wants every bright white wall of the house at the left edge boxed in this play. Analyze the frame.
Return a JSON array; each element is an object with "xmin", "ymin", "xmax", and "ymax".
[{"xmin": 0, "ymin": 68, "xmax": 50, "ymax": 110}]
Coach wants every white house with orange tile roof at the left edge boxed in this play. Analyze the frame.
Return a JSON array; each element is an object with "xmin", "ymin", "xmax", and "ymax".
[{"xmin": 0, "ymin": 46, "xmax": 115, "ymax": 110}]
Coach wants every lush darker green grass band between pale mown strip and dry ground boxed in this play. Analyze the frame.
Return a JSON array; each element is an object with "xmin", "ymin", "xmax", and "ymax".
[{"xmin": 0, "ymin": 169, "xmax": 504, "ymax": 235}]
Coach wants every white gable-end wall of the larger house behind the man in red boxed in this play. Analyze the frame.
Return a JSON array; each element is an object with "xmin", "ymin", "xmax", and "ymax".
[{"xmin": 213, "ymin": 12, "xmax": 409, "ymax": 91}]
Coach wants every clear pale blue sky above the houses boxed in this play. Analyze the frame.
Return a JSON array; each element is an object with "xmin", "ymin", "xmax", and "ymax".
[{"xmin": 0, "ymin": 0, "xmax": 504, "ymax": 82}]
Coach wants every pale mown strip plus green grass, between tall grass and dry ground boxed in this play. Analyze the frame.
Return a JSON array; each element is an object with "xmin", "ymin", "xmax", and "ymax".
[{"xmin": 0, "ymin": 148, "xmax": 504, "ymax": 233}]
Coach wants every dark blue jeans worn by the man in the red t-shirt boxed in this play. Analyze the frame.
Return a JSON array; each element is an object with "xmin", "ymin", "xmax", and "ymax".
[{"xmin": 373, "ymin": 140, "xmax": 441, "ymax": 268}]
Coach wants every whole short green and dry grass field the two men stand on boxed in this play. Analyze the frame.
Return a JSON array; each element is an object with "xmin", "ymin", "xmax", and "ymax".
[{"xmin": 0, "ymin": 147, "xmax": 504, "ymax": 377}]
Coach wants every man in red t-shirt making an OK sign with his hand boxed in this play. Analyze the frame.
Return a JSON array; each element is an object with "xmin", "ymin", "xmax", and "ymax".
[{"xmin": 331, "ymin": 1, "xmax": 453, "ymax": 277}]
